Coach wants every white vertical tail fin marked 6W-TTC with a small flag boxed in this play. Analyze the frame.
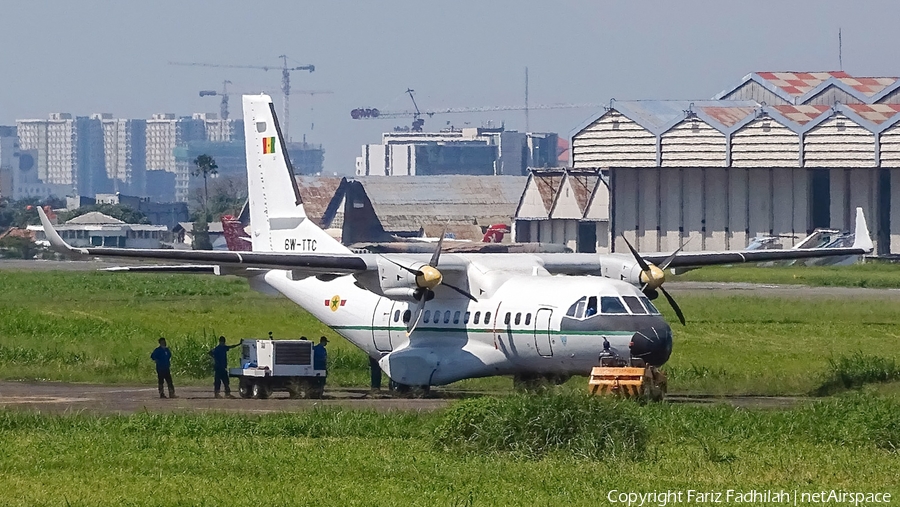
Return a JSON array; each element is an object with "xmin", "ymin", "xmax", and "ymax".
[{"xmin": 243, "ymin": 95, "xmax": 350, "ymax": 253}]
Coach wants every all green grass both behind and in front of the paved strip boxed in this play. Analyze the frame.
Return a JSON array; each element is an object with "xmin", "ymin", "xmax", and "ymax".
[{"xmin": 0, "ymin": 268, "xmax": 900, "ymax": 506}]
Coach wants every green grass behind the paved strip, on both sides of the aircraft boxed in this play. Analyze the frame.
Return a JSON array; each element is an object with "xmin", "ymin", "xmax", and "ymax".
[{"xmin": 0, "ymin": 268, "xmax": 900, "ymax": 394}]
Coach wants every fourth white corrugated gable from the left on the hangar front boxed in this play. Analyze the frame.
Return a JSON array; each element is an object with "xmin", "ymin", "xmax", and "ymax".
[{"xmin": 803, "ymin": 115, "xmax": 875, "ymax": 167}]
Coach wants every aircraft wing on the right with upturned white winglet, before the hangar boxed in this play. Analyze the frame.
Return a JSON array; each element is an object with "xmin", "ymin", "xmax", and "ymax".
[{"xmin": 641, "ymin": 208, "xmax": 874, "ymax": 268}]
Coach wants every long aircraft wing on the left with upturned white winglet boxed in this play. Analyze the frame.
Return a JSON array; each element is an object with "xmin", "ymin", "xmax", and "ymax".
[{"xmin": 38, "ymin": 209, "xmax": 369, "ymax": 276}]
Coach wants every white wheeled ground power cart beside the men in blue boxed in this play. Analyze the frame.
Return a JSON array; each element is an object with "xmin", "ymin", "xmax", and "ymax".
[{"xmin": 228, "ymin": 340, "xmax": 326, "ymax": 400}]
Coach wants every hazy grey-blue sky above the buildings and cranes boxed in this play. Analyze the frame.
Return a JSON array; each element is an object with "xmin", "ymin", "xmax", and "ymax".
[{"xmin": 0, "ymin": 0, "xmax": 900, "ymax": 175}]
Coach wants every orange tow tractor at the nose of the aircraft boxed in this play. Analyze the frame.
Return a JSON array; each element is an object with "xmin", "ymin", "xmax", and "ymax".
[{"xmin": 588, "ymin": 354, "xmax": 668, "ymax": 401}]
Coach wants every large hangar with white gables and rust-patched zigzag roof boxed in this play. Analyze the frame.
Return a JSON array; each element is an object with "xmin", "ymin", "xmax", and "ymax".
[{"xmin": 568, "ymin": 72, "xmax": 900, "ymax": 254}]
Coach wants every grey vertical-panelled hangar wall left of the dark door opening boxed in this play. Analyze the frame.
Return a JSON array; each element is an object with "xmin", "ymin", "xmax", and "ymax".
[{"xmin": 611, "ymin": 167, "xmax": 812, "ymax": 252}]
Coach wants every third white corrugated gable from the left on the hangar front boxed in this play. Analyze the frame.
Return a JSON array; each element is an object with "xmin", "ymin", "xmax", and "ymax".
[{"xmin": 731, "ymin": 118, "xmax": 800, "ymax": 167}]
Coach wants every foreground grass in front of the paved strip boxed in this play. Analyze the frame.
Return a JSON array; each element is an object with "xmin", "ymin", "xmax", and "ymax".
[{"xmin": 0, "ymin": 395, "xmax": 900, "ymax": 506}]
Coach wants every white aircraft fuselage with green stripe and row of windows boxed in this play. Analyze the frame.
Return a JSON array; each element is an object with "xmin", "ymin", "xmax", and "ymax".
[{"xmin": 256, "ymin": 270, "xmax": 671, "ymax": 385}]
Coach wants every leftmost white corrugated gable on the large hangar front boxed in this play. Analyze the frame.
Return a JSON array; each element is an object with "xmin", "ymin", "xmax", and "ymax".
[{"xmin": 572, "ymin": 111, "xmax": 656, "ymax": 169}]
